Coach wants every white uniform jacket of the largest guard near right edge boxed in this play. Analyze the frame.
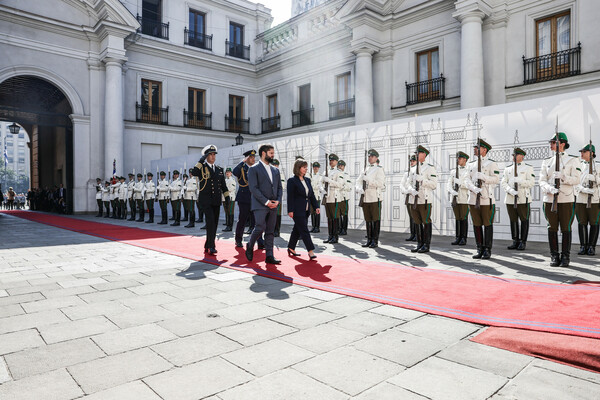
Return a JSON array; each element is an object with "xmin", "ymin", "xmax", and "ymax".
[{"xmin": 539, "ymin": 153, "xmax": 581, "ymax": 203}]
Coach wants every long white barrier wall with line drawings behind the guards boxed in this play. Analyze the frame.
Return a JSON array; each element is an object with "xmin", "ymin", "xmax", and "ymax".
[{"xmin": 152, "ymin": 89, "xmax": 600, "ymax": 241}]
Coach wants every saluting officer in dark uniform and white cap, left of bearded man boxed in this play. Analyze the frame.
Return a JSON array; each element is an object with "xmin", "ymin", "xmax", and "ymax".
[{"xmin": 191, "ymin": 144, "xmax": 231, "ymax": 255}]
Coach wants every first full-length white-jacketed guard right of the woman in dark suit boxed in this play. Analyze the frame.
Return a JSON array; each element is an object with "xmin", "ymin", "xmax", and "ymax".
[{"xmin": 321, "ymin": 153, "xmax": 346, "ymax": 244}]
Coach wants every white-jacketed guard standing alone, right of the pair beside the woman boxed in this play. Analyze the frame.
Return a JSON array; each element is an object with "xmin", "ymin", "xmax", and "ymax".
[{"xmin": 356, "ymin": 149, "xmax": 385, "ymax": 248}]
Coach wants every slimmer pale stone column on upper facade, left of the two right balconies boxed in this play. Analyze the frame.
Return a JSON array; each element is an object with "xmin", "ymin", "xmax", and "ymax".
[{"xmin": 354, "ymin": 48, "xmax": 374, "ymax": 125}]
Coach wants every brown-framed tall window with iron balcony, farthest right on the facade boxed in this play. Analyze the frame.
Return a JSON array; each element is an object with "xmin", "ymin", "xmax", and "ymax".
[{"xmin": 536, "ymin": 11, "xmax": 571, "ymax": 75}]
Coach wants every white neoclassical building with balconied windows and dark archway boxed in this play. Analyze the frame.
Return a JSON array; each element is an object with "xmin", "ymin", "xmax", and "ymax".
[{"xmin": 0, "ymin": 0, "xmax": 600, "ymax": 212}]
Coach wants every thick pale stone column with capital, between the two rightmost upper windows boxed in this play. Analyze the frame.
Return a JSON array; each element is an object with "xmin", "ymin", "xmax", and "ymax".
[{"xmin": 453, "ymin": 0, "xmax": 489, "ymax": 108}]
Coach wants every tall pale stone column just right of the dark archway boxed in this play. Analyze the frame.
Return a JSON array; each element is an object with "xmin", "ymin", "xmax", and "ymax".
[{"xmin": 103, "ymin": 58, "xmax": 124, "ymax": 177}]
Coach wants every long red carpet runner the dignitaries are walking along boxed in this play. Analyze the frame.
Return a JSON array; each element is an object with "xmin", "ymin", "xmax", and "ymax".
[{"xmin": 3, "ymin": 211, "xmax": 600, "ymax": 338}]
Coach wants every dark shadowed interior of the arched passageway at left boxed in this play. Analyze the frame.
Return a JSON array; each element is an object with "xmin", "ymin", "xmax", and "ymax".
[{"xmin": 0, "ymin": 75, "xmax": 74, "ymax": 213}]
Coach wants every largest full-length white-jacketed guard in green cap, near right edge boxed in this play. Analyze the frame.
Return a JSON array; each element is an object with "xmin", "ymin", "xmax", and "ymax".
[{"xmin": 539, "ymin": 132, "xmax": 581, "ymax": 267}]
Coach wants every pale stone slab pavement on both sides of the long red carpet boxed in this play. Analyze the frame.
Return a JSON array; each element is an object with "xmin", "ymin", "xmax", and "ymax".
[{"xmin": 0, "ymin": 214, "xmax": 600, "ymax": 400}]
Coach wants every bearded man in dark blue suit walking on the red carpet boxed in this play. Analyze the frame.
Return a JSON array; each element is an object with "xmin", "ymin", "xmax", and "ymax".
[{"xmin": 246, "ymin": 144, "xmax": 283, "ymax": 264}]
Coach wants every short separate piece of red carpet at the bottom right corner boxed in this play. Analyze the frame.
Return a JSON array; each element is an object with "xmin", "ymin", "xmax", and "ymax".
[{"xmin": 471, "ymin": 328, "xmax": 600, "ymax": 372}]
